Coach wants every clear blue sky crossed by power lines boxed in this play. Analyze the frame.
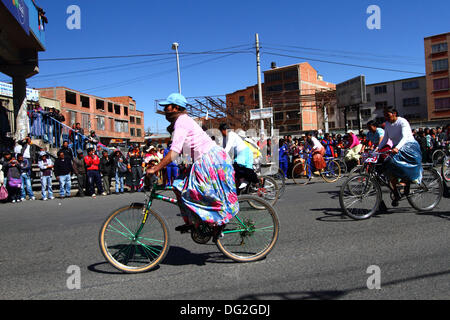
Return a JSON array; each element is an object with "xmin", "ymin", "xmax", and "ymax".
[{"xmin": 5, "ymin": 0, "xmax": 450, "ymax": 131}]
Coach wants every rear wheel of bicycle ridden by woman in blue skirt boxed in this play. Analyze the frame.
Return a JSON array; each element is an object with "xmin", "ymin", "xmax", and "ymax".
[{"xmin": 407, "ymin": 168, "xmax": 444, "ymax": 211}]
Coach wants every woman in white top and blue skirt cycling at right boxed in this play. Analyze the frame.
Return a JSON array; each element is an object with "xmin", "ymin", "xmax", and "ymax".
[{"xmin": 377, "ymin": 107, "xmax": 423, "ymax": 207}]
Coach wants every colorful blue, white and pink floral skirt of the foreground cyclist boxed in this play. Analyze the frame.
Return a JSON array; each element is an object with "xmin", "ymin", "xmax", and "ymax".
[{"xmin": 173, "ymin": 146, "xmax": 239, "ymax": 226}]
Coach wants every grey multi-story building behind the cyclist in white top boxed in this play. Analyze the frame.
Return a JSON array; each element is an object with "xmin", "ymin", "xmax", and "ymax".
[{"xmin": 354, "ymin": 76, "xmax": 428, "ymax": 129}]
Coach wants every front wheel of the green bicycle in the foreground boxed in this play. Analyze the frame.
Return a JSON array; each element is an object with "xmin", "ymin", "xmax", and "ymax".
[{"xmin": 99, "ymin": 203, "xmax": 169, "ymax": 273}]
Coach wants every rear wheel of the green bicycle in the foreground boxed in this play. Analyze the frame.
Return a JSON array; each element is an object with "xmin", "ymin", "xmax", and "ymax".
[{"xmin": 216, "ymin": 195, "xmax": 279, "ymax": 262}]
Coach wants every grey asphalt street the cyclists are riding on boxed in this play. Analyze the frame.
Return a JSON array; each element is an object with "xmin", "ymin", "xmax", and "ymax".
[{"xmin": 0, "ymin": 179, "xmax": 450, "ymax": 300}]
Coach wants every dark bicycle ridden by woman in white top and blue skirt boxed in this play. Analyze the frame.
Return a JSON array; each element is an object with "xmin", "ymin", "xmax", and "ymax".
[{"xmin": 339, "ymin": 153, "xmax": 444, "ymax": 220}]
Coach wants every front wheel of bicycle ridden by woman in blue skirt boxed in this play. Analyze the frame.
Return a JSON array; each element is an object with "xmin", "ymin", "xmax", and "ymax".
[{"xmin": 339, "ymin": 174, "xmax": 382, "ymax": 220}]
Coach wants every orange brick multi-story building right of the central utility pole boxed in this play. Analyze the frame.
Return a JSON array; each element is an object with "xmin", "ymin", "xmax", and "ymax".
[{"xmin": 264, "ymin": 62, "xmax": 336, "ymax": 135}]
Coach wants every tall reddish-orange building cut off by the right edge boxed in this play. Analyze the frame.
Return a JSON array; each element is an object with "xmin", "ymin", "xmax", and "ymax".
[{"xmin": 424, "ymin": 32, "xmax": 450, "ymax": 120}]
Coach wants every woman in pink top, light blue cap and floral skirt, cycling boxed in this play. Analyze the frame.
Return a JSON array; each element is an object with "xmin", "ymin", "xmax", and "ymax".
[{"xmin": 146, "ymin": 93, "xmax": 239, "ymax": 231}]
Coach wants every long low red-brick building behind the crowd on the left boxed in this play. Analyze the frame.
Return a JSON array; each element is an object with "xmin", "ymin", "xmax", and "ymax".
[{"xmin": 38, "ymin": 87, "xmax": 145, "ymax": 146}]
